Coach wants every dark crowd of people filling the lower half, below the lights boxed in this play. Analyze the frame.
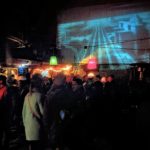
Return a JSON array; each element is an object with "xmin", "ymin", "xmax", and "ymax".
[{"xmin": 0, "ymin": 73, "xmax": 150, "ymax": 150}]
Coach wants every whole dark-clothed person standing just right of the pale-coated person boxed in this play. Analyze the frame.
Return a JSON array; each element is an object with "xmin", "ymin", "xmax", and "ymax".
[{"xmin": 44, "ymin": 74, "xmax": 71, "ymax": 149}]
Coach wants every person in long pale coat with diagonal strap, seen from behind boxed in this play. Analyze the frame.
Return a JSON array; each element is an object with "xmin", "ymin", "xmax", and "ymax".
[{"xmin": 22, "ymin": 75, "xmax": 43, "ymax": 150}]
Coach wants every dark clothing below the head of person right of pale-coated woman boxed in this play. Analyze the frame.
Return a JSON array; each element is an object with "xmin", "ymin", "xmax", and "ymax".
[{"xmin": 43, "ymin": 85, "xmax": 72, "ymax": 146}]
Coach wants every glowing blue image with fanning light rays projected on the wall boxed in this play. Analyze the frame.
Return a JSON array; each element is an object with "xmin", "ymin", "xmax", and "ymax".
[{"xmin": 58, "ymin": 12, "xmax": 150, "ymax": 64}]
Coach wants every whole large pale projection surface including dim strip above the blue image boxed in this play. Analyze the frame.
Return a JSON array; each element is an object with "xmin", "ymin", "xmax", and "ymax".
[{"xmin": 57, "ymin": 3, "xmax": 150, "ymax": 67}]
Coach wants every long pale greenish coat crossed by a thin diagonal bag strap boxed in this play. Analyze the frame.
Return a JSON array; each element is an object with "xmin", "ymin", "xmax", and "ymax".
[{"xmin": 22, "ymin": 92, "xmax": 43, "ymax": 141}]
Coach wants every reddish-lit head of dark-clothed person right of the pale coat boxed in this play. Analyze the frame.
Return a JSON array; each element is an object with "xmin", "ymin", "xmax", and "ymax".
[{"xmin": 53, "ymin": 73, "xmax": 66, "ymax": 86}]
